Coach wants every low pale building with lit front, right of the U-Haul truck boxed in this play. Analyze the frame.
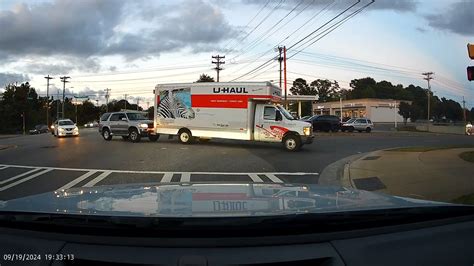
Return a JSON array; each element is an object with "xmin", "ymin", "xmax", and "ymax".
[{"xmin": 313, "ymin": 98, "xmax": 411, "ymax": 123}]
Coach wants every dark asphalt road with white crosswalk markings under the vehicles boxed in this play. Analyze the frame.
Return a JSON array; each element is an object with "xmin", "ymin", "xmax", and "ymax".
[{"xmin": 0, "ymin": 129, "xmax": 474, "ymax": 200}]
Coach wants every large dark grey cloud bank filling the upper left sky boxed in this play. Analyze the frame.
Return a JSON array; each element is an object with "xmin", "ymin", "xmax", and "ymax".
[{"xmin": 0, "ymin": 0, "xmax": 234, "ymax": 63}]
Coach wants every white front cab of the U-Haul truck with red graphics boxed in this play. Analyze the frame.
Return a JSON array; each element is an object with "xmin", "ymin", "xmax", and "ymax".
[{"xmin": 253, "ymin": 102, "xmax": 313, "ymax": 151}]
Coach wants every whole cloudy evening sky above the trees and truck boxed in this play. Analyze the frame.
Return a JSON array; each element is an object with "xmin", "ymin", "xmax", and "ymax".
[{"xmin": 0, "ymin": 0, "xmax": 474, "ymax": 108}]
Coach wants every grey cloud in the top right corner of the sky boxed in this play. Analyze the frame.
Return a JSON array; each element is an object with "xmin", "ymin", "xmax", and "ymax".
[{"xmin": 425, "ymin": 0, "xmax": 474, "ymax": 36}]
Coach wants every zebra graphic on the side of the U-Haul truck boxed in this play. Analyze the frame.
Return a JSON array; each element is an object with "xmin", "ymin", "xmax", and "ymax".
[{"xmin": 157, "ymin": 88, "xmax": 196, "ymax": 119}]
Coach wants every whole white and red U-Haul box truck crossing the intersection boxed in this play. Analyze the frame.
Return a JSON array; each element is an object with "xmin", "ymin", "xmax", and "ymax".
[{"xmin": 154, "ymin": 82, "xmax": 313, "ymax": 151}]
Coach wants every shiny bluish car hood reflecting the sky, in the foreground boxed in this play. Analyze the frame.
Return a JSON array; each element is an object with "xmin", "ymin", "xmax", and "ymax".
[{"xmin": 0, "ymin": 183, "xmax": 450, "ymax": 217}]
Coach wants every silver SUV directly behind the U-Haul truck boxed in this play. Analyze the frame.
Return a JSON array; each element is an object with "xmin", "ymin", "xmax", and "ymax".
[{"xmin": 99, "ymin": 111, "xmax": 159, "ymax": 142}]
